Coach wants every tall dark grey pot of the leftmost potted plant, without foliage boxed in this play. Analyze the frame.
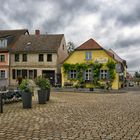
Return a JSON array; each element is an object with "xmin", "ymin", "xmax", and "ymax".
[{"xmin": 22, "ymin": 91, "xmax": 32, "ymax": 108}]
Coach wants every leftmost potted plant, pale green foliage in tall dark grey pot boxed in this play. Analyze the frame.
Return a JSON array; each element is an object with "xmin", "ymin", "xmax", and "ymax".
[{"xmin": 19, "ymin": 79, "xmax": 32, "ymax": 108}]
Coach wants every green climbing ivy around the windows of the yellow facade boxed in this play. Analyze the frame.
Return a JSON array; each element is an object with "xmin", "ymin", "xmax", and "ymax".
[{"xmin": 63, "ymin": 61, "xmax": 115, "ymax": 85}]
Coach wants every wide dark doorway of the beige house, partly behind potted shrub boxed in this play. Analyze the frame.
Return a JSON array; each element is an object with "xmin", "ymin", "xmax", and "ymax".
[{"xmin": 42, "ymin": 70, "xmax": 55, "ymax": 86}]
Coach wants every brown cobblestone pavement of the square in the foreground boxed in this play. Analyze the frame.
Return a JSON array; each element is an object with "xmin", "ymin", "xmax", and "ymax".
[{"xmin": 0, "ymin": 93, "xmax": 140, "ymax": 140}]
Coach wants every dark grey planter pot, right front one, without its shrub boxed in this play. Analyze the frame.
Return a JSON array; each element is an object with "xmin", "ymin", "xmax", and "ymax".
[{"xmin": 38, "ymin": 90, "xmax": 47, "ymax": 104}]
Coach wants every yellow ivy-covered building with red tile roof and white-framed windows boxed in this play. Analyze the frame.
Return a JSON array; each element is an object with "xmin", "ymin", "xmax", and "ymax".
[{"xmin": 61, "ymin": 39, "xmax": 126, "ymax": 89}]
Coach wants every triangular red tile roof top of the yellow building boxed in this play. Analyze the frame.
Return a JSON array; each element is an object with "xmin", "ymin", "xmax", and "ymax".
[{"xmin": 75, "ymin": 38, "xmax": 103, "ymax": 50}]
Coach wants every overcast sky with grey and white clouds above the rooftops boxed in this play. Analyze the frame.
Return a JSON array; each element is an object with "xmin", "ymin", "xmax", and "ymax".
[{"xmin": 0, "ymin": 0, "xmax": 140, "ymax": 71}]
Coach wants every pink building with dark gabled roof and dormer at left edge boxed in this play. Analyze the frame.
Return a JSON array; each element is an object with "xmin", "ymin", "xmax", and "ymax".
[{"xmin": 0, "ymin": 29, "xmax": 29, "ymax": 87}]
